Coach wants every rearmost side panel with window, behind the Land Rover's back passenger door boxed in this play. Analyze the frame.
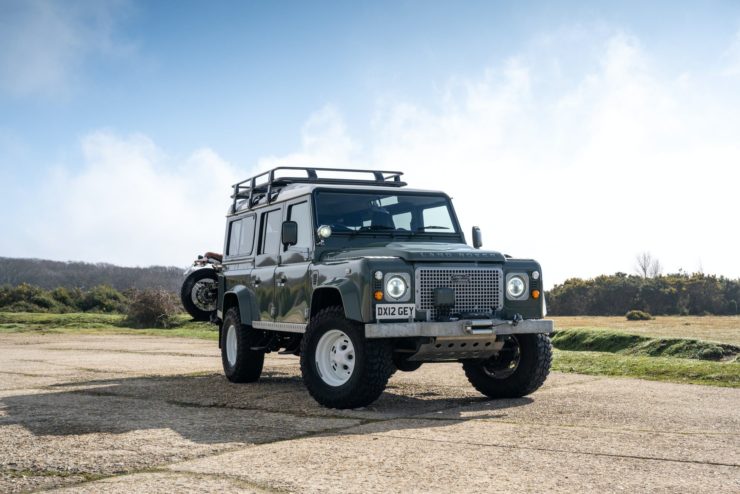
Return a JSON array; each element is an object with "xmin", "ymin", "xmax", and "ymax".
[{"xmin": 222, "ymin": 213, "xmax": 256, "ymax": 308}]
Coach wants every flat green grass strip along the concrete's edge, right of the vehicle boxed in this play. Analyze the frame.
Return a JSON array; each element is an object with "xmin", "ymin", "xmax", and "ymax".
[{"xmin": 552, "ymin": 349, "xmax": 740, "ymax": 388}]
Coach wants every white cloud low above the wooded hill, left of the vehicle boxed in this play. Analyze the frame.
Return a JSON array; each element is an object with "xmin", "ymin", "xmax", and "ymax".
[{"xmin": 13, "ymin": 132, "xmax": 244, "ymax": 266}]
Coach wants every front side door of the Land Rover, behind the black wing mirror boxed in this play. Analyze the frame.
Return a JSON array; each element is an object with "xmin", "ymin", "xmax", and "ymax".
[{"xmin": 275, "ymin": 196, "xmax": 314, "ymax": 324}]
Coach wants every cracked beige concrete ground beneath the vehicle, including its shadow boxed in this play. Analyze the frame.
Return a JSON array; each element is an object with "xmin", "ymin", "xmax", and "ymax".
[{"xmin": 0, "ymin": 334, "xmax": 740, "ymax": 493}]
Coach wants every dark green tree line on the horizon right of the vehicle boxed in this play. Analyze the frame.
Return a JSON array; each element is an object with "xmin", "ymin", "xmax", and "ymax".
[{"xmin": 546, "ymin": 273, "xmax": 740, "ymax": 316}]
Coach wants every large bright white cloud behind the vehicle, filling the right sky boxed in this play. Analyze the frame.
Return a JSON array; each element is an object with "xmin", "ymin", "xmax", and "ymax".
[{"xmin": 254, "ymin": 33, "xmax": 740, "ymax": 284}]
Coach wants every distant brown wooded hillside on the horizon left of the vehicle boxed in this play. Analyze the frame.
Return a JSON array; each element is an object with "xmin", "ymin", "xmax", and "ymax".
[{"xmin": 0, "ymin": 257, "xmax": 183, "ymax": 292}]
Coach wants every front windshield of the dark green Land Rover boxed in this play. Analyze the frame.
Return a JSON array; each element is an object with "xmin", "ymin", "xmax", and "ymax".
[{"xmin": 316, "ymin": 191, "xmax": 458, "ymax": 234}]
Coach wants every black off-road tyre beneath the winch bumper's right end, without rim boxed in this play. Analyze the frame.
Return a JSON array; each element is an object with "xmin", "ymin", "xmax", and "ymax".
[{"xmin": 463, "ymin": 334, "xmax": 552, "ymax": 398}]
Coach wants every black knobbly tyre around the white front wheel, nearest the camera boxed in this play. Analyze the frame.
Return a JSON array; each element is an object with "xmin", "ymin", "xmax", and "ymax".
[{"xmin": 301, "ymin": 306, "xmax": 395, "ymax": 408}]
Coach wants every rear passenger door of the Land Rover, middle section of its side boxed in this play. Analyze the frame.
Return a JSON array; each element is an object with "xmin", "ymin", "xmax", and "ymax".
[{"xmin": 251, "ymin": 206, "xmax": 283, "ymax": 322}]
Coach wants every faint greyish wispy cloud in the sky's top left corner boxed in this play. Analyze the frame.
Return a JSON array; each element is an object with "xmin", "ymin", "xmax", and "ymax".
[{"xmin": 0, "ymin": 0, "xmax": 132, "ymax": 96}]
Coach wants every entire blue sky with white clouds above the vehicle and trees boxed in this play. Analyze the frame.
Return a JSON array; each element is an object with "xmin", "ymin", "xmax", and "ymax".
[{"xmin": 0, "ymin": 0, "xmax": 740, "ymax": 282}]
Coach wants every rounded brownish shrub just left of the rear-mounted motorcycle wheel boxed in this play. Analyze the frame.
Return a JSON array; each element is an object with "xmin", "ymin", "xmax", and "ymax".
[{"xmin": 124, "ymin": 289, "xmax": 180, "ymax": 329}]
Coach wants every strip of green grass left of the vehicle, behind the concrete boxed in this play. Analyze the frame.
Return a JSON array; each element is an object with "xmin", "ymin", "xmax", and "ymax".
[{"xmin": 0, "ymin": 312, "xmax": 218, "ymax": 340}]
